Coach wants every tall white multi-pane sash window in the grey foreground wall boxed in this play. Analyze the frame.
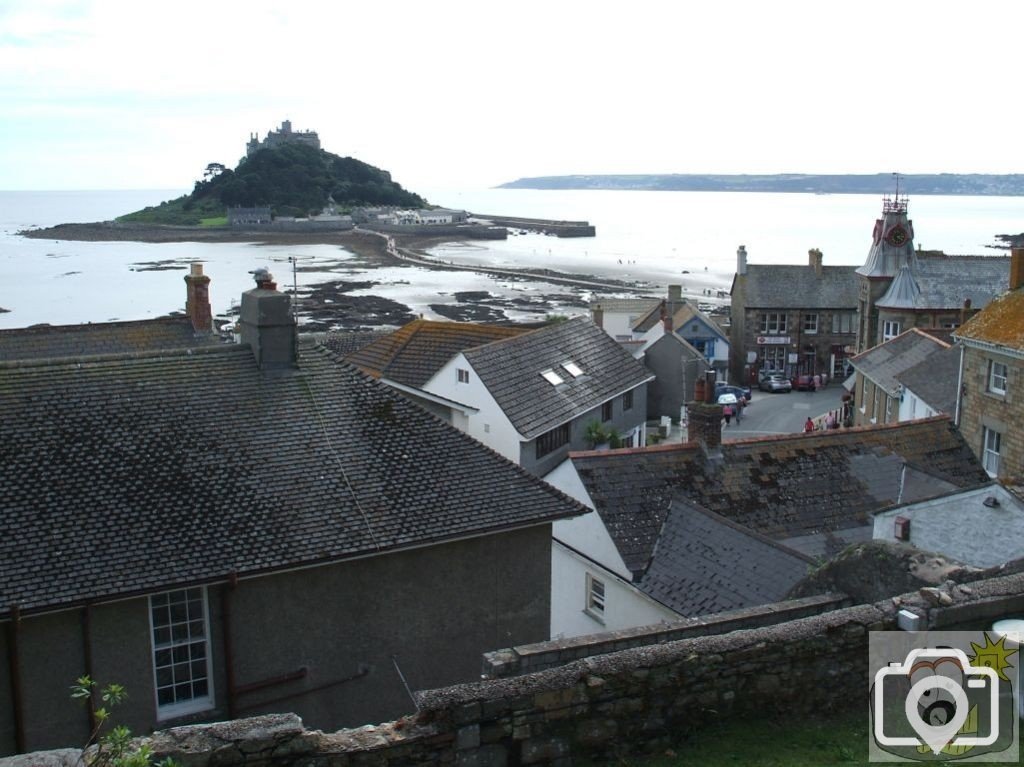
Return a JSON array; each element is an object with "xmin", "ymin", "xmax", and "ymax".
[{"xmin": 147, "ymin": 586, "xmax": 214, "ymax": 721}]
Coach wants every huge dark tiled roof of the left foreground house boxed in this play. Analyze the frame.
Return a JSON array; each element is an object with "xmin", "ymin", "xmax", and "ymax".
[{"xmin": 0, "ymin": 340, "xmax": 584, "ymax": 614}]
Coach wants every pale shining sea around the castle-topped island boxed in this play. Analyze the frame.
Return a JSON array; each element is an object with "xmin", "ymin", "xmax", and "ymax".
[{"xmin": 0, "ymin": 187, "xmax": 1024, "ymax": 328}]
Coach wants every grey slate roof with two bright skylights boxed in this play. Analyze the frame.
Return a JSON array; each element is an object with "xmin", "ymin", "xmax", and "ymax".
[{"xmin": 465, "ymin": 316, "xmax": 654, "ymax": 439}]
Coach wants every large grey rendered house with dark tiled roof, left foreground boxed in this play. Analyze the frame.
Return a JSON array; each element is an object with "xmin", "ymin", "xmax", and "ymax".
[{"xmin": 0, "ymin": 270, "xmax": 586, "ymax": 754}]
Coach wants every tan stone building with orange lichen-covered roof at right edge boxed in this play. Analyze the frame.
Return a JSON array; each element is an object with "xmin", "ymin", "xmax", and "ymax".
[{"xmin": 953, "ymin": 248, "xmax": 1024, "ymax": 481}]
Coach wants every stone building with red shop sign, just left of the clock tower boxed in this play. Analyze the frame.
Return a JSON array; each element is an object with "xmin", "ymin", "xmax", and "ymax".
[{"xmin": 729, "ymin": 245, "xmax": 857, "ymax": 385}]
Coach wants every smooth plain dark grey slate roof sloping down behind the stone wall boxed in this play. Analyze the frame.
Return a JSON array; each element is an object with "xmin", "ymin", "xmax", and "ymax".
[{"xmin": 638, "ymin": 499, "xmax": 813, "ymax": 616}]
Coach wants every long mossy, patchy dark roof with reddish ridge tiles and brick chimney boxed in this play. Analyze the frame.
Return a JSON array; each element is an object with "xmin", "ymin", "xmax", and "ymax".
[{"xmin": 571, "ymin": 416, "xmax": 989, "ymax": 572}]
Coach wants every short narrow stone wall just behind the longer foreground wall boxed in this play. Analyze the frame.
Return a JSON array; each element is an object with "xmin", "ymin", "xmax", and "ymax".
[{"xmin": 482, "ymin": 594, "xmax": 853, "ymax": 679}]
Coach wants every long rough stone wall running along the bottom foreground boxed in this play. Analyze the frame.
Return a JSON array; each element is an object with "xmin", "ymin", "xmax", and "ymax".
[{"xmin": 12, "ymin": 573, "xmax": 1024, "ymax": 767}]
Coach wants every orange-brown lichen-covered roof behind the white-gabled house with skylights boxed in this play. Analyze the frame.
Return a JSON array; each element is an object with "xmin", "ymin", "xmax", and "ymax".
[{"xmin": 346, "ymin": 319, "xmax": 529, "ymax": 388}]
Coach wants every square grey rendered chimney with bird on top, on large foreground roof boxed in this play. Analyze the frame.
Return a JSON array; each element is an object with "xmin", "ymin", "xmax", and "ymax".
[{"xmin": 239, "ymin": 268, "xmax": 298, "ymax": 370}]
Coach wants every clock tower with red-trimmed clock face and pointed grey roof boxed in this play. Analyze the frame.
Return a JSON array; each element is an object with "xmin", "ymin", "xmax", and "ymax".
[{"xmin": 856, "ymin": 192, "xmax": 918, "ymax": 353}]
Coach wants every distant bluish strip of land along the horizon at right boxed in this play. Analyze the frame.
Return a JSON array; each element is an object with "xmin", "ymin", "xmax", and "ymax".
[{"xmin": 498, "ymin": 173, "xmax": 1024, "ymax": 197}]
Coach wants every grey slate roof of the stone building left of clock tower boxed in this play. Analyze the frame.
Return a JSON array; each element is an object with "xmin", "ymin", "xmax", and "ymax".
[{"xmin": 745, "ymin": 264, "xmax": 858, "ymax": 309}]
